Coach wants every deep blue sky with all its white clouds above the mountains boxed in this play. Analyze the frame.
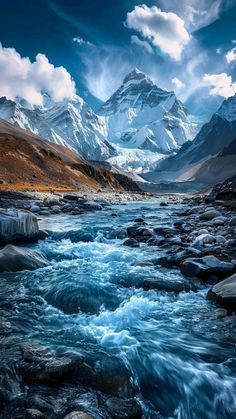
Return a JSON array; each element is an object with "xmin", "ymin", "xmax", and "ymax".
[{"xmin": 0, "ymin": 0, "xmax": 236, "ymax": 114}]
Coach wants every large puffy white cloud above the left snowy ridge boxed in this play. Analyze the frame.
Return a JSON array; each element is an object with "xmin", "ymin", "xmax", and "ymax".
[{"xmin": 0, "ymin": 43, "xmax": 75, "ymax": 105}]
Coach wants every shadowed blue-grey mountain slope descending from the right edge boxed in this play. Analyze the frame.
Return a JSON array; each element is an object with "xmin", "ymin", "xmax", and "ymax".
[{"xmin": 145, "ymin": 95, "xmax": 236, "ymax": 188}]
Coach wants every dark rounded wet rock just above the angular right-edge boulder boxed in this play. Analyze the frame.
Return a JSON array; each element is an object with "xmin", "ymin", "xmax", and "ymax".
[{"xmin": 180, "ymin": 256, "xmax": 234, "ymax": 280}]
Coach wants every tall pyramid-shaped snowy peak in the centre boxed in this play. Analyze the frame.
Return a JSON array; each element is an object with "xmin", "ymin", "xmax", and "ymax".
[{"xmin": 98, "ymin": 69, "xmax": 197, "ymax": 171}]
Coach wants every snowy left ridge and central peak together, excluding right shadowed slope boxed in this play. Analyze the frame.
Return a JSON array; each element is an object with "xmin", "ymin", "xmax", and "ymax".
[{"xmin": 0, "ymin": 69, "xmax": 197, "ymax": 172}]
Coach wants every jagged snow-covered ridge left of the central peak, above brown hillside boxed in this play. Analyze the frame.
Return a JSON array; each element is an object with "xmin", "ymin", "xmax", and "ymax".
[{"xmin": 0, "ymin": 95, "xmax": 115, "ymax": 160}]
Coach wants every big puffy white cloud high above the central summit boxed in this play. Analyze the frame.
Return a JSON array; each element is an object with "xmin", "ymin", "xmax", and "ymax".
[{"xmin": 126, "ymin": 4, "xmax": 190, "ymax": 60}]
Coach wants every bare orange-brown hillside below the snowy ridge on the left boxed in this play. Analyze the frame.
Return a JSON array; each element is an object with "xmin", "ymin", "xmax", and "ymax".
[{"xmin": 0, "ymin": 119, "xmax": 138, "ymax": 190}]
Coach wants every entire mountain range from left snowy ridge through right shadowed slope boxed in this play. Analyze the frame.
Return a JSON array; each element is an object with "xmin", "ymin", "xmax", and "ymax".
[{"xmin": 0, "ymin": 69, "xmax": 236, "ymax": 189}]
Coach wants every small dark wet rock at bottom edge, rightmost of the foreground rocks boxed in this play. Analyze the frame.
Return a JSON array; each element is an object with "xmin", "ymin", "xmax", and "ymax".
[{"xmin": 105, "ymin": 397, "xmax": 142, "ymax": 419}]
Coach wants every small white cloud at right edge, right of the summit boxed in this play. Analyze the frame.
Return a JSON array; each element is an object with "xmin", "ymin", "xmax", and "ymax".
[{"xmin": 202, "ymin": 73, "xmax": 236, "ymax": 98}]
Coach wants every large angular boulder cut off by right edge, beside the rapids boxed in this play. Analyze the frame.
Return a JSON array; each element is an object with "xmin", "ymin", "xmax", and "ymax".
[{"xmin": 207, "ymin": 274, "xmax": 236, "ymax": 310}]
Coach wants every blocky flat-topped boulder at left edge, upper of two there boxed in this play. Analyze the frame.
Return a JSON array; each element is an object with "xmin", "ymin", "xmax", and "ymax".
[{"xmin": 0, "ymin": 208, "xmax": 39, "ymax": 244}]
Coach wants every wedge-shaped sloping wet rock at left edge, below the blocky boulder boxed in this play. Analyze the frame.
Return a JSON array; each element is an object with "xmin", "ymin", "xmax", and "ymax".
[{"xmin": 0, "ymin": 244, "xmax": 49, "ymax": 272}]
